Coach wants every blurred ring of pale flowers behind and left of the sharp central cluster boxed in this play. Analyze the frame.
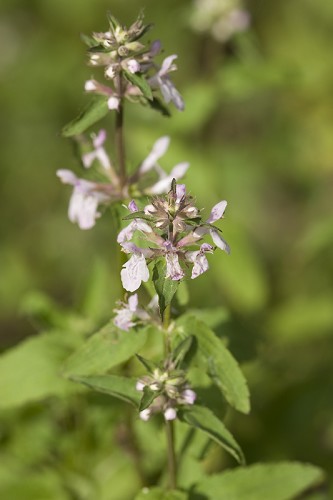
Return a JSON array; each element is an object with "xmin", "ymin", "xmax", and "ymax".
[{"xmin": 57, "ymin": 130, "xmax": 189, "ymax": 229}]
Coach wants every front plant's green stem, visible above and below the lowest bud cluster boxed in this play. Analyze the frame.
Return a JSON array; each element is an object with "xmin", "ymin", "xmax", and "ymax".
[{"xmin": 163, "ymin": 304, "xmax": 177, "ymax": 490}]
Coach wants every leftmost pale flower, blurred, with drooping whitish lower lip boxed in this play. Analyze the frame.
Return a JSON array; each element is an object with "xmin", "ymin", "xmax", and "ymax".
[{"xmin": 57, "ymin": 169, "xmax": 107, "ymax": 229}]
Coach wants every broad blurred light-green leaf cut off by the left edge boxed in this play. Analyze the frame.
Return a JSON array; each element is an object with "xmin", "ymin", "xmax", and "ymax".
[{"xmin": 0, "ymin": 331, "xmax": 80, "ymax": 409}]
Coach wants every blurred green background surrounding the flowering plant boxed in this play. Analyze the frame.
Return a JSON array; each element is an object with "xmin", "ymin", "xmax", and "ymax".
[{"xmin": 0, "ymin": 0, "xmax": 333, "ymax": 499}]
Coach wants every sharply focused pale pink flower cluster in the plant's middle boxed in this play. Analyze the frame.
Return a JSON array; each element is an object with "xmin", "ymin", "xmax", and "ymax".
[{"xmin": 117, "ymin": 180, "xmax": 230, "ymax": 292}]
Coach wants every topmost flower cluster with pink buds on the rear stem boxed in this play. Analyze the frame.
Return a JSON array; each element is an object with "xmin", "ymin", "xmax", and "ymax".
[{"xmin": 84, "ymin": 15, "xmax": 184, "ymax": 110}]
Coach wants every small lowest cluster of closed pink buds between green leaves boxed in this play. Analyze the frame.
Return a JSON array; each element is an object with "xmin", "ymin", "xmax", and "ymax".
[{"xmin": 136, "ymin": 363, "xmax": 196, "ymax": 421}]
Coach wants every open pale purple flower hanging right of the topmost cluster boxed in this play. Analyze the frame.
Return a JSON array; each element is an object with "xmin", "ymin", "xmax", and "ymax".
[{"xmin": 148, "ymin": 54, "xmax": 184, "ymax": 111}]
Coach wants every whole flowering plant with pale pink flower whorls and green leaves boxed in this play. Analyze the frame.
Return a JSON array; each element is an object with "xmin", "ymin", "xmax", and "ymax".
[{"xmin": 52, "ymin": 8, "xmax": 320, "ymax": 500}]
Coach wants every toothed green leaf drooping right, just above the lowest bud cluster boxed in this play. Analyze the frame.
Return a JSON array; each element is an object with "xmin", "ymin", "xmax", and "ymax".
[{"xmin": 177, "ymin": 316, "xmax": 250, "ymax": 413}]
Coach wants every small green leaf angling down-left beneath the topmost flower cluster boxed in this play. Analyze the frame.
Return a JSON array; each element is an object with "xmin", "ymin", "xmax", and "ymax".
[{"xmin": 62, "ymin": 96, "xmax": 109, "ymax": 137}]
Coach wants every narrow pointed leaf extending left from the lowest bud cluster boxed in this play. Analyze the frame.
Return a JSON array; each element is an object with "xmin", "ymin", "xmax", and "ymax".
[{"xmin": 71, "ymin": 375, "xmax": 141, "ymax": 408}]
